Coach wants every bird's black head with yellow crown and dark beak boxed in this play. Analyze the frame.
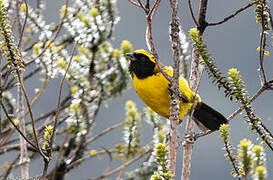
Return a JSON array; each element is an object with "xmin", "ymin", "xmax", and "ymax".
[{"xmin": 126, "ymin": 50, "xmax": 156, "ymax": 79}]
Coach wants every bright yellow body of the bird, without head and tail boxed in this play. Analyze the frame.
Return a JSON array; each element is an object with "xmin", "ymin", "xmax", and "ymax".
[{"xmin": 133, "ymin": 69, "xmax": 201, "ymax": 119}]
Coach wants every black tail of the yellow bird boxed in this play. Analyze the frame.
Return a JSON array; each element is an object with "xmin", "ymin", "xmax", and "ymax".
[{"xmin": 193, "ymin": 102, "xmax": 228, "ymax": 131}]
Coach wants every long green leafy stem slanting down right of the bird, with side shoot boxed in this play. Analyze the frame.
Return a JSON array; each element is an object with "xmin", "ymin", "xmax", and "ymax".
[{"xmin": 190, "ymin": 28, "xmax": 273, "ymax": 148}]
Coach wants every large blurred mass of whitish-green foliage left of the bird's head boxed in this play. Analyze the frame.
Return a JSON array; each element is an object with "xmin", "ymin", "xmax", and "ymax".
[{"xmin": 16, "ymin": 0, "xmax": 132, "ymax": 143}]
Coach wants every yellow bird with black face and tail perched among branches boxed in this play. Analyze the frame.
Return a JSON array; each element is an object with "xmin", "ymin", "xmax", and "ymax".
[{"xmin": 126, "ymin": 49, "xmax": 228, "ymax": 131}]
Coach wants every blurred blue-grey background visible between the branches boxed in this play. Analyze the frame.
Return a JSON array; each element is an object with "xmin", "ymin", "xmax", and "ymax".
[{"xmin": 1, "ymin": 0, "xmax": 273, "ymax": 180}]
